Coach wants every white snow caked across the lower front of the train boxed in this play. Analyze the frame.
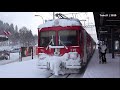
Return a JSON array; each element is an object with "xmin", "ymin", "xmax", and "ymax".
[{"xmin": 38, "ymin": 52, "xmax": 81, "ymax": 76}]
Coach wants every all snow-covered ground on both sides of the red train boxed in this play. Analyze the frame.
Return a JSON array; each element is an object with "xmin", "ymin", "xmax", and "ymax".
[{"xmin": 0, "ymin": 50, "xmax": 120, "ymax": 78}]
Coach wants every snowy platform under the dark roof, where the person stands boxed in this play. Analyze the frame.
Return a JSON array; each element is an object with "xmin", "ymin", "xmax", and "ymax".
[{"xmin": 83, "ymin": 49, "xmax": 120, "ymax": 78}]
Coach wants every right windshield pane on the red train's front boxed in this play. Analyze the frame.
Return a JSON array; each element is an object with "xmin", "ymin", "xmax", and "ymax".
[{"xmin": 58, "ymin": 30, "xmax": 78, "ymax": 46}]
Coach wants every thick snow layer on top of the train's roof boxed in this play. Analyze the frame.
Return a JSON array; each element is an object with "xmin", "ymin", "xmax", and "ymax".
[{"xmin": 38, "ymin": 19, "xmax": 82, "ymax": 29}]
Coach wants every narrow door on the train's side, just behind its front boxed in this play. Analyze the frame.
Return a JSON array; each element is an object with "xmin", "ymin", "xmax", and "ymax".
[{"xmin": 83, "ymin": 30, "xmax": 87, "ymax": 64}]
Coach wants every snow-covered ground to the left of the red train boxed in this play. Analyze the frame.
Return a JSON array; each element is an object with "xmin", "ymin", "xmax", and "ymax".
[{"xmin": 0, "ymin": 57, "xmax": 50, "ymax": 78}]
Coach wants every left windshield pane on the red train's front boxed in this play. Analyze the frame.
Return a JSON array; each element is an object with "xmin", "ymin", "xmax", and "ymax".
[{"xmin": 40, "ymin": 31, "xmax": 56, "ymax": 47}]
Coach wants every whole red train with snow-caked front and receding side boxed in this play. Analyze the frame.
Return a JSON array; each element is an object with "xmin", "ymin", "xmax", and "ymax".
[{"xmin": 38, "ymin": 14, "xmax": 96, "ymax": 69}]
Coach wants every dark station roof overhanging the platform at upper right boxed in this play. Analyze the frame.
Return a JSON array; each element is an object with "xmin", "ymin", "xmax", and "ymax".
[{"xmin": 93, "ymin": 12, "xmax": 120, "ymax": 40}]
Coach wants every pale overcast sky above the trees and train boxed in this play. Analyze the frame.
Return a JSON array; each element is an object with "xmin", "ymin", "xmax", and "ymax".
[{"xmin": 0, "ymin": 12, "xmax": 96, "ymax": 42}]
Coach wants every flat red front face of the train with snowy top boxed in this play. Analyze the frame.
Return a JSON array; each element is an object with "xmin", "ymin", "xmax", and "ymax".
[{"xmin": 38, "ymin": 19, "xmax": 82, "ymax": 70}]
